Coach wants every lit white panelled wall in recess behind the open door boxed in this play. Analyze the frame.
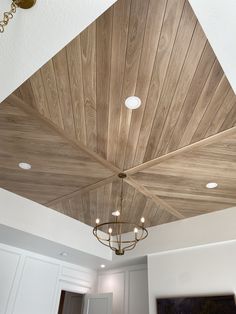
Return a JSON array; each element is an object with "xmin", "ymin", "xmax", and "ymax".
[{"xmin": 98, "ymin": 265, "xmax": 148, "ymax": 314}]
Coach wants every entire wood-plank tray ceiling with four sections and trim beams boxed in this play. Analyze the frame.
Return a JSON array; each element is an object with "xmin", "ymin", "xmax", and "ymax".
[{"xmin": 0, "ymin": 0, "xmax": 236, "ymax": 231}]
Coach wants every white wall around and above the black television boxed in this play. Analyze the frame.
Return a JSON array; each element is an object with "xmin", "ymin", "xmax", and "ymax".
[{"xmin": 148, "ymin": 240, "xmax": 236, "ymax": 314}]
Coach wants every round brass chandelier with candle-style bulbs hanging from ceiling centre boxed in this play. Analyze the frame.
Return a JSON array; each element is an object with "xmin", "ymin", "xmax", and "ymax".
[{"xmin": 93, "ymin": 173, "xmax": 148, "ymax": 255}]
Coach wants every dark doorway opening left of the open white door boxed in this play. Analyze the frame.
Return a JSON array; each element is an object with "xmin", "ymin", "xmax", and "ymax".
[{"xmin": 58, "ymin": 290, "xmax": 84, "ymax": 314}]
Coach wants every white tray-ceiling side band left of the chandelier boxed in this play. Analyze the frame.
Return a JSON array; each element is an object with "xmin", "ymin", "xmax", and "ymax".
[{"xmin": 0, "ymin": 188, "xmax": 112, "ymax": 260}]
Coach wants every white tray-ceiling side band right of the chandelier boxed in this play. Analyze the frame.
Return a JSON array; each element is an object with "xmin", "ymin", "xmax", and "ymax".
[{"xmin": 113, "ymin": 207, "xmax": 236, "ymax": 262}]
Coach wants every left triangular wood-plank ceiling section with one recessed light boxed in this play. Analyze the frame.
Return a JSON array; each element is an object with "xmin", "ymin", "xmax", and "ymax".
[{"xmin": 0, "ymin": 96, "xmax": 114, "ymax": 204}]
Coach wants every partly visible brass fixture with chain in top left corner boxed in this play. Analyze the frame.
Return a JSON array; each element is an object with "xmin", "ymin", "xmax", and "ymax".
[{"xmin": 0, "ymin": 0, "xmax": 36, "ymax": 33}]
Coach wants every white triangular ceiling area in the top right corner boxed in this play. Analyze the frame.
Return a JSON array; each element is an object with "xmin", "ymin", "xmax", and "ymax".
[{"xmin": 189, "ymin": 0, "xmax": 236, "ymax": 93}]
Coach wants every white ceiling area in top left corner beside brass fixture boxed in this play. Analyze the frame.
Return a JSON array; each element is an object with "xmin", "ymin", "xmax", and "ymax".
[{"xmin": 0, "ymin": 0, "xmax": 116, "ymax": 102}]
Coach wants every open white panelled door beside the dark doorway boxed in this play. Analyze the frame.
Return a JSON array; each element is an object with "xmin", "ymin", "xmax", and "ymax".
[{"xmin": 83, "ymin": 293, "xmax": 112, "ymax": 314}]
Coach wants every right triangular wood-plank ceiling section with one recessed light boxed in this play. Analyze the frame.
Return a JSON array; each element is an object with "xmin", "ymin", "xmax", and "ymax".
[{"xmin": 132, "ymin": 130, "xmax": 236, "ymax": 217}]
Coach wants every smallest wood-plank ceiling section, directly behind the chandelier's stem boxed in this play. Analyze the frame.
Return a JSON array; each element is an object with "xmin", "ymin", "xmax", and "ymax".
[{"xmin": 51, "ymin": 179, "xmax": 177, "ymax": 232}]
